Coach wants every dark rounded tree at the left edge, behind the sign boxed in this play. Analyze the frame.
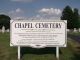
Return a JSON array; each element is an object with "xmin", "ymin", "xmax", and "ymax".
[{"xmin": 0, "ymin": 14, "xmax": 11, "ymax": 29}]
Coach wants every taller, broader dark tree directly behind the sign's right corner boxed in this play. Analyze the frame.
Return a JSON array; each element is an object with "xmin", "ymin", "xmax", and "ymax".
[{"xmin": 61, "ymin": 6, "xmax": 74, "ymax": 29}]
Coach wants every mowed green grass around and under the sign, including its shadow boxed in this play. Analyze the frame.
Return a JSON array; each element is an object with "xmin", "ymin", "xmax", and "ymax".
[{"xmin": 0, "ymin": 33, "xmax": 80, "ymax": 60}]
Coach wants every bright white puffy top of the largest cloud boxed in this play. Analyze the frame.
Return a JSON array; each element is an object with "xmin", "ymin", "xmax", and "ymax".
[{"xmin": 39, "ymin": 8, "xmax": 61, "ymax": 15}]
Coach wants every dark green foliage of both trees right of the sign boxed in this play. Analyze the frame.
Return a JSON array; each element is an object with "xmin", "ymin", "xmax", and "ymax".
[{"xmin": 61, "ymin": 6, "xmax": 80, "ymax": 29}]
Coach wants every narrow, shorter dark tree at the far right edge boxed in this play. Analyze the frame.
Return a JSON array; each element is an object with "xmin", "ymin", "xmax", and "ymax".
[{"xmin": 73, "ymin": 8, "xmax": 80, "ymax": 29}]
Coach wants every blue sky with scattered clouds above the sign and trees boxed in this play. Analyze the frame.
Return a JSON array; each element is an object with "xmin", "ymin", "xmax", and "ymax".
[{"xmin": 0, "ymin": 0, "xmax": 80, "ymax": 19}]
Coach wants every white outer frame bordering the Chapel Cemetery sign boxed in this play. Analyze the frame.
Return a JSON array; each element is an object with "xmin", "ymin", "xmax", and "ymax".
[{"xmin": 10, "ymin": 20, "xmax": 67, "ymax": 48}]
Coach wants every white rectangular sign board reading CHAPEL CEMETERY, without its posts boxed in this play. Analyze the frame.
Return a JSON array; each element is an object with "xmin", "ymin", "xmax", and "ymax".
[{"xmin": 10, "ymin": 20, "xmax": 67, "ymax": 47}]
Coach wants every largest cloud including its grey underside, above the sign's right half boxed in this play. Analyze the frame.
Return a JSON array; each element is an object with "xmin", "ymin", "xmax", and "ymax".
[{"xmin": 36, "ymin": 8, "xmax": 61, "ymax": 19}]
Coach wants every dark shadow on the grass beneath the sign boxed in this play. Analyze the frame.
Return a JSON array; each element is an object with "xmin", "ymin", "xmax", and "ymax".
[{"xmin": 21, "ymin": 47, "xmax": 62, "ymax": 58}]
